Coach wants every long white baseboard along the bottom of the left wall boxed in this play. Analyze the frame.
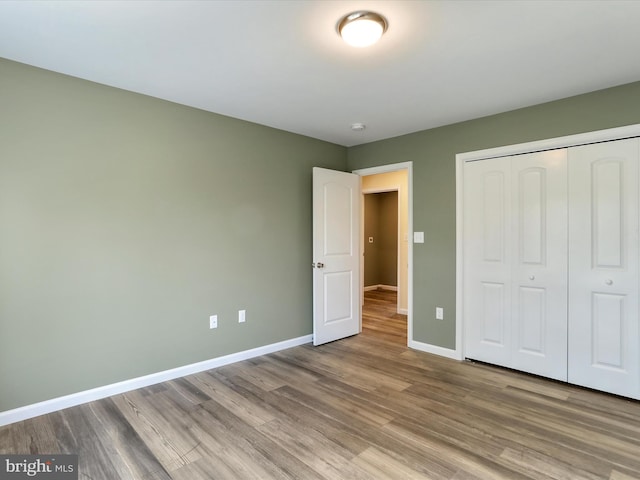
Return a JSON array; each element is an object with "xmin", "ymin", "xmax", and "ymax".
[{"xmin": 0, "ymin": 335, "xmax": 313, "ymax": 427}]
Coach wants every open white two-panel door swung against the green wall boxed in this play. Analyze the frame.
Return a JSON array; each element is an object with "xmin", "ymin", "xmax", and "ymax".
[{"xmin": 313, "ymin": 167, "xmax": 362, "ymax": 345}]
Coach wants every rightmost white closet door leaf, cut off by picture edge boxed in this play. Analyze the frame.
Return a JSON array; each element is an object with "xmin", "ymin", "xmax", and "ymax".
[{"xmin": 569, "ymin": 138, "xmax": 640, "ymax": 398}]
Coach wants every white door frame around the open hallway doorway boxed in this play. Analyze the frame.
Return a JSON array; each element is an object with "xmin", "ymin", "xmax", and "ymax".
[{"xmin": 351, "ymin": 162, "xmax": 414, "ymax": 347}]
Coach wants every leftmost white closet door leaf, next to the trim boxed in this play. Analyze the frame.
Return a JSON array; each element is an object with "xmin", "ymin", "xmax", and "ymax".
[{"xmin": 464, "ymin": 158, "xmax": 511, "ymax": 366}]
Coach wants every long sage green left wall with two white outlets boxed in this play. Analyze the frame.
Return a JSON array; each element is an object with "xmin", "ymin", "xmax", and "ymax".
[{"xmin": 0, "ymin": 60, "xmax": 347, "ymax": 411}]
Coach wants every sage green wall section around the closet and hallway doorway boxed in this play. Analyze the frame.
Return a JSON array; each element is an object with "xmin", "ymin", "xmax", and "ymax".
[{"xmin": 348, "ymin": 82, "xmax": 640, "ymax": 349}]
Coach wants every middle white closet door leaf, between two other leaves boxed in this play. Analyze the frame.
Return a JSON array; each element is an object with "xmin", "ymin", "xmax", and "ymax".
[{"xmin": 511, "ymin": 149, "xmax": 567, "ymax": 380}]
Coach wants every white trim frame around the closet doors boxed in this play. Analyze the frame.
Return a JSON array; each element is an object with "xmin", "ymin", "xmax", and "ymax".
[{"xmin": 454, "ymin": 124, "xmax": 640, "ymax": 360}]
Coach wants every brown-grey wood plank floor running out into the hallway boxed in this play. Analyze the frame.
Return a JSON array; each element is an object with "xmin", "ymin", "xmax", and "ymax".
[{"xmin": 0, "ymin": 292, "xmax": 640, "ymax": 480}]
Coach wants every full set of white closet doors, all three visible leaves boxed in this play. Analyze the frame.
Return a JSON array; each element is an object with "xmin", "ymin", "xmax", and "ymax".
[{"xmin": 463, "ymin": 138, "xmax": 640, "ymax": 399}]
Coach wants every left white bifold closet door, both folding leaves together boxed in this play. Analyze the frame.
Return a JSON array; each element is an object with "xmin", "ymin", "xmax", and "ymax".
[{"xmin": 464, "ymin": 149, "xmax": 567, "ymax": 380}]
